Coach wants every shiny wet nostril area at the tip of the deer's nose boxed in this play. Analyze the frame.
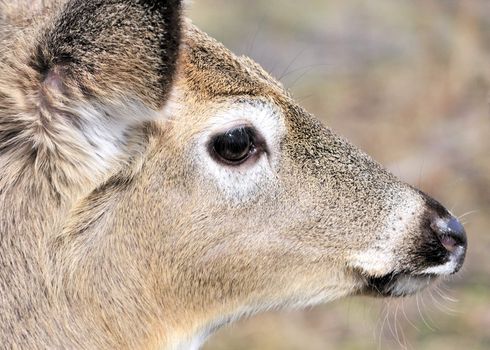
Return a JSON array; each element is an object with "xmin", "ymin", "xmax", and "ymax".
[{"xmin": 430, "ymin": 216, "xmax": 467, "ymax": 252}]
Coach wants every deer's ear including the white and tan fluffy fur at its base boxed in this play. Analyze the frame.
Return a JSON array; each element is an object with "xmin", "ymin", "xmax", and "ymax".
[{"xmin": 0, "ymin": 0, "xmax": 181, "ymax": 191}]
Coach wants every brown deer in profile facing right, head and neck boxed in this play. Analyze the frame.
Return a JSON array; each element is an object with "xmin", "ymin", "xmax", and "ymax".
[{"xmin": 0, "ymin": 0, "xmax": 467, "ymax": 349}]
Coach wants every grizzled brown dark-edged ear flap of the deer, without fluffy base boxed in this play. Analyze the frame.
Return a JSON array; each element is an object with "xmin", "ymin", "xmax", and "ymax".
[{"xmin": 32, "ymin": 0, "xmax": 181, "ymax": 108}]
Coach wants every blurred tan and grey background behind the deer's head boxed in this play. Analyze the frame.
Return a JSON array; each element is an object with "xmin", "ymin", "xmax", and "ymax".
[{"xmin": 188, "ymin": 0, "xmax": 490, "ymax": 350}]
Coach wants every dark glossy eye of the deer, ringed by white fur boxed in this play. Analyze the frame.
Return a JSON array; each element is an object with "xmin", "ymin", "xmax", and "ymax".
[{"xmin": 210, "ymin": 126, "xmax": 257, "ymax": 165}]
